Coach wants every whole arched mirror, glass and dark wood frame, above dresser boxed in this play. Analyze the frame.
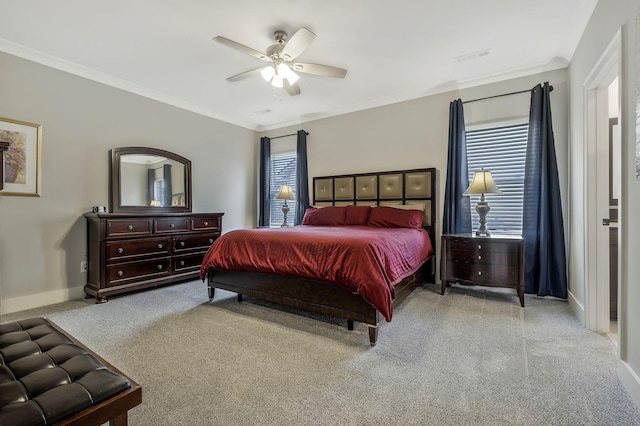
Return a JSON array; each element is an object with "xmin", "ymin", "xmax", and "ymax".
[{"xmin": 110, "ymin": 147, "xmax": 191, "ymax": 213}]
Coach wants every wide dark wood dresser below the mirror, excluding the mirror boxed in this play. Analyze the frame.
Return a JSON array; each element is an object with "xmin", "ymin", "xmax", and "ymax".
[{"xmin": 84, "ymin": 213, "xmax": 224, "ymax": 303}]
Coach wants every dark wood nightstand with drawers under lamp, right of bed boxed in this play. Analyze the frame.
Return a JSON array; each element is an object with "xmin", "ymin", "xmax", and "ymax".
[{"xmin": 440, "ymin": 234, "xmax": 524, "ymax": 307}]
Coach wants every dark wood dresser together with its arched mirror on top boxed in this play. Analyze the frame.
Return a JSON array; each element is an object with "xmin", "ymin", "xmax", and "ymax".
[{"xmin": 84, "ymin": 147, "xmax": 224, "ymax": 303}]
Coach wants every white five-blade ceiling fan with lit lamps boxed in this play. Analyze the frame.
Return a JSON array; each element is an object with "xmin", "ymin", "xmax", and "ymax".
[{"xmin": 213, "ymin": 27, "xmax": 347, "ymax": 96}]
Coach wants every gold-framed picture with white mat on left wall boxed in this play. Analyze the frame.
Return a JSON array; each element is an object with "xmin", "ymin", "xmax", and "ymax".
[{"xmin": 0, "ymin": 117, "xmax": 42, "ymax": 197}]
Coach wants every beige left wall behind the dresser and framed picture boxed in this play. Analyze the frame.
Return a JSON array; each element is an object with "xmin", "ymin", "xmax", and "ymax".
[{"xmin": 0, "ymin": 53, "xmax": 256, "ymax": 313}]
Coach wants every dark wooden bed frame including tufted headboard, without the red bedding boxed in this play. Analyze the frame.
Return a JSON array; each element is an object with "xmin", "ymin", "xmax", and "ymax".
[{"xmin": 207, "ymin": 168, "xmax": 437, "ymax": 346}]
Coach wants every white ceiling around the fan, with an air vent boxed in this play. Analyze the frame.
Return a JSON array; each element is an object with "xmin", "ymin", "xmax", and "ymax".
[{"xmin": 0, "ymin": 0, "xmax": 597, "ymax": 130}]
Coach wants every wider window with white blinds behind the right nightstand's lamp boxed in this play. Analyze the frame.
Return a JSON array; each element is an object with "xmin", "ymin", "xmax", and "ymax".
[{"xmin": 465, "ymin": 123, "xmax": 529, "ymax": 234}]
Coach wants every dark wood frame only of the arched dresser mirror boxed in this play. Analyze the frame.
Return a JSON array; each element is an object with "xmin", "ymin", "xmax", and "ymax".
[{"xmin": 109, "ymin": 147, "xmax": 191, "ymax": 214}]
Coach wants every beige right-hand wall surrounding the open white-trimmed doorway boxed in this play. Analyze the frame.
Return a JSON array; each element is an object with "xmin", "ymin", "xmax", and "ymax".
[{"xmin": 569, "ymin": 0, "xmax": 640, "ymax": 405}]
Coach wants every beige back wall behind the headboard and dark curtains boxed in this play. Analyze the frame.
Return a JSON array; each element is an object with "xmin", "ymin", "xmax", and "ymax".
[{"xmin": 260, "ymin": 69, "xmax": 569, "ymax": 282}]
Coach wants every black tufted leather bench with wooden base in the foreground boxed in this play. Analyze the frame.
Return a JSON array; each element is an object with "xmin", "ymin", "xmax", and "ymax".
[{"xmin": 0, "ymin": 318, "xmax": 142, "ymax": 426}]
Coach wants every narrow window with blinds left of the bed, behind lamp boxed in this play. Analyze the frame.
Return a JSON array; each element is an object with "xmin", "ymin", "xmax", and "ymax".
[{"xmin": 269, "ymin": 151, "xmax": 297, "ymax": 227}]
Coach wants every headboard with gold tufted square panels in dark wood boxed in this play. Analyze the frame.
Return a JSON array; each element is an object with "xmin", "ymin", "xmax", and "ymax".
[{"xmin": 312, "ymin": 168, "xmax": 437, "ymax": 254}]
